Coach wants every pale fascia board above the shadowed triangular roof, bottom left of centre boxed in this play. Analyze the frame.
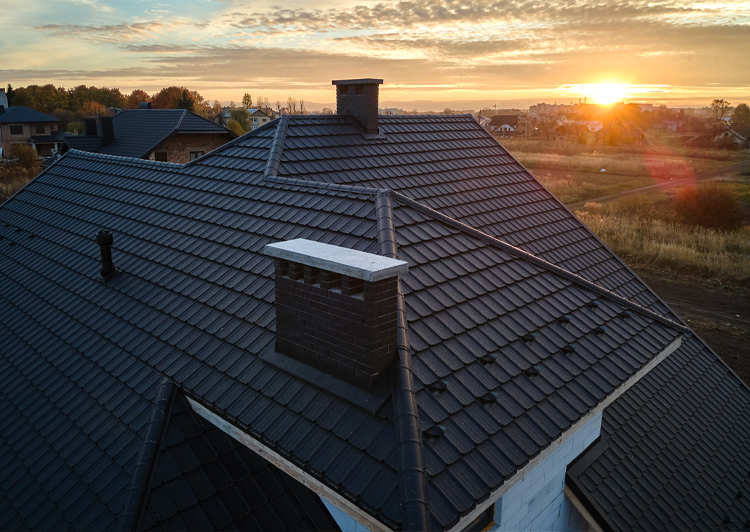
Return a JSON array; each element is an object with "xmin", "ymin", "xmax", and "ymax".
[{"xmin": 187, "ymin": 397, "xmax": 392, "ymax": 532}]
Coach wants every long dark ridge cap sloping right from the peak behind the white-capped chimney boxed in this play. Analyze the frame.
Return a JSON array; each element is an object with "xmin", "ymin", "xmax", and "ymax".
[{"xmin": 392, "ymin": 192, "xmax": 693, "ymax": 333}]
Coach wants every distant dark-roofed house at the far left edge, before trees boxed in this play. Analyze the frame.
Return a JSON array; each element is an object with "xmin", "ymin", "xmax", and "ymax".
[{"xmin": 0, "ymin": 105, "xmax": 67, "ymax": 157}]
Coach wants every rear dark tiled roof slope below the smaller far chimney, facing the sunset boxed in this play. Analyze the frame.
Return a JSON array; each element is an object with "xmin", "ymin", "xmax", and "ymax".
[{"xmin": 278, "ymin": 115, "xmax": 674, "ymax": 317}]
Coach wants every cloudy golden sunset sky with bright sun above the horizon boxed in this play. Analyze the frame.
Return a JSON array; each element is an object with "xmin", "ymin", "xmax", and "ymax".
[{"xmin": 0, "ymin": 0, "xmax": 750, "ymax": 111}]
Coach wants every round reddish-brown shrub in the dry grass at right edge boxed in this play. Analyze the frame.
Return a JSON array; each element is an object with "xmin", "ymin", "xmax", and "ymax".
[{"xmin": 675, "ymin": 183, "xmax": 745, "ymax": 231}]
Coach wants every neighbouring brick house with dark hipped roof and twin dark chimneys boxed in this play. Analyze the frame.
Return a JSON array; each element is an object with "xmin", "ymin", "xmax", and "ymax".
[{"xmin": 61, "ymin": 109, "xmax": 237, "ymax": 163}]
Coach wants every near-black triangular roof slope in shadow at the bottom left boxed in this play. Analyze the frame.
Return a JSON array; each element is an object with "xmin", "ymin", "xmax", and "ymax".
[{"xmin": 140, "ymin": 393, "xmax": 339, "ymax": 532}]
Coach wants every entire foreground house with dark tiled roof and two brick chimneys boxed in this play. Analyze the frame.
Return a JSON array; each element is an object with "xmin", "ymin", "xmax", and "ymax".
[{"xmin": 0, "ymin": 79, "xmax": 750, "ymax": 531}]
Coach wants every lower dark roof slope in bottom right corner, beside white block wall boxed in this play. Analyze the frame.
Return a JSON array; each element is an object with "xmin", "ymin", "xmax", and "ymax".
[{"xmin": 568, "ymin": 339, "xmax": 750, "ymax": 532}]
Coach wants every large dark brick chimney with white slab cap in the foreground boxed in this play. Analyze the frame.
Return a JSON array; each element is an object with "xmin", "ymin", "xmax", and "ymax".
[{"xmin": 264, "ymin": 239, "xmax": 409, "ymax": 391}]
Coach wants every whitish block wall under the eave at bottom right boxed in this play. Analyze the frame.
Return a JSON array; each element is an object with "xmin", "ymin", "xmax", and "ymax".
[{"xmin": 490, "ymin": 413, "xmax": 602, "ymax": 532}]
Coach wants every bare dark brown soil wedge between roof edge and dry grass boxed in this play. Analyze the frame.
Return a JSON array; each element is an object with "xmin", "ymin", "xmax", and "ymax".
[{"xmin": 636, "ymin": 269, "xmax": 750, "ymax": 384}]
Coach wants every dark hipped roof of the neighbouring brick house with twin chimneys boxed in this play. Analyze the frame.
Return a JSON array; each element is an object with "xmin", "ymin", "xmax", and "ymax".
[{"xmin": 60, "ymin": 109, "xmax": 237, "ymax": 158}]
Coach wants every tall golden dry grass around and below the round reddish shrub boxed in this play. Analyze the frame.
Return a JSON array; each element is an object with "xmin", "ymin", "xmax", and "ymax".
[{"xmin": 576, "ymin": 194, "xmax": 750, "ymax": 287}]
